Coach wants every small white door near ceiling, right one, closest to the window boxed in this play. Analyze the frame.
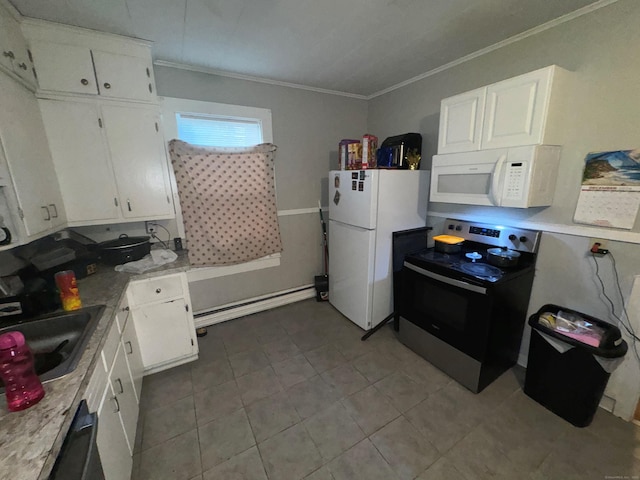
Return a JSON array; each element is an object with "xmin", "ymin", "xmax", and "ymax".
[{"xmin": 92, "ymin": 50, "xmax": 156, "ymax": 101}]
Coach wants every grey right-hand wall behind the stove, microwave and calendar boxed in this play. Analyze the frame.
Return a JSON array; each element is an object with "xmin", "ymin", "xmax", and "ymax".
[{"xmin": 368, "ymin": 0, "xmax": 640, "ymax": 418}]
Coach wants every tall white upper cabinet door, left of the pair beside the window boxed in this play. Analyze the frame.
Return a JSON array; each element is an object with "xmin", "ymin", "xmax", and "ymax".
[{"xmin": 39, "ymin": 100, "xmax": 119, "ymax": 225}]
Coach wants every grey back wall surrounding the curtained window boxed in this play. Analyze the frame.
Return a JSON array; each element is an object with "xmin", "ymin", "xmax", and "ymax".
[{"xmin": 155, "ymin": 66, "xmax": 367, "ymax": 312}]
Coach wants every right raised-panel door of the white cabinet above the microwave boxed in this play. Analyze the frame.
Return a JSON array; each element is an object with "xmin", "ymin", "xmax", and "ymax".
[{"xmin": 482, "ymin": 68, "xmax": 552, "ymax": 149}]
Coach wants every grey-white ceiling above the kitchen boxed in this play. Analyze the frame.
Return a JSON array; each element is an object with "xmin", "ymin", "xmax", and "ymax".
[{"xmin": 9, "ymin": 0, "xmax": 611, "ymax": 97}]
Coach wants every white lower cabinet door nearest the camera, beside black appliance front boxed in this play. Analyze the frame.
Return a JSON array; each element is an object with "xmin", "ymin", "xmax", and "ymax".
[{"xmin": 97, "ymin": 383, "xmax": 133, "ymax": 480}]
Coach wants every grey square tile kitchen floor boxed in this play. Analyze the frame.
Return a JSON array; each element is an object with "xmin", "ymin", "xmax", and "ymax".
[{"xmin": 132, "ymin": 300, "xmax": 640, "ymax": 480}]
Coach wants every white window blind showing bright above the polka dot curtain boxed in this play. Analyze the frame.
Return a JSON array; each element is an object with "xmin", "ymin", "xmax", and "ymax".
[{"xmin": 176, "ymin": 113, "xmax": 263, "ymax": 147}]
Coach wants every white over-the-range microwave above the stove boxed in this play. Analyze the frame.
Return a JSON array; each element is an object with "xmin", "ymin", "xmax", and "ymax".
[{"xmin": 429, "ymin": 145, "xmax": 560, "ymax": 208}]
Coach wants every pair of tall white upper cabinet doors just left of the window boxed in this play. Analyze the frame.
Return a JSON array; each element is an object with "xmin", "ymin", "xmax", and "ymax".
[{"xmin": 39, "ymin": 99, "xmax": 175, "ymax": 226}]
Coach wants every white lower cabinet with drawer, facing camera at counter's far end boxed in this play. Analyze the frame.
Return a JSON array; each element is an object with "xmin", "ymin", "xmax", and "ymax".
[{"xmin": 128, "ymin": 273, "xmax": 198, "ymax": 373}]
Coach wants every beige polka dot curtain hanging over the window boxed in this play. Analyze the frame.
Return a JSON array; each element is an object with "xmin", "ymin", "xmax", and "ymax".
[{"xmin": 169, "ymin": 140, "xmax": 282, "ymax": 266}]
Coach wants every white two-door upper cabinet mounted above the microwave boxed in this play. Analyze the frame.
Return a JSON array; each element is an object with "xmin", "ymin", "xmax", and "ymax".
[{"xmin": 438, "ymin": 65, "xmax": 569, "ymax": 154}]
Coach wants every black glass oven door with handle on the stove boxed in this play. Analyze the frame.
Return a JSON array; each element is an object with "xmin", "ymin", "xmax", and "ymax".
[{"xmin": 399, "ymin": 262, "xmax": 493, "ymax": 361}]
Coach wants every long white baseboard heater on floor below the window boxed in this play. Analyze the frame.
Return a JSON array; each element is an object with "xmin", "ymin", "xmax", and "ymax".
[{"xmin": 193, "ymin": 285, "xmax": 316, "ymax": 328}]
